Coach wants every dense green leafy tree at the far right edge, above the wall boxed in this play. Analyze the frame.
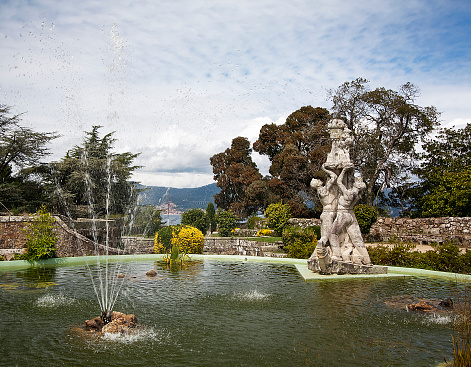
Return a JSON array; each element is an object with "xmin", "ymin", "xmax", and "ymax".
[{"xmin": 394, "ymin": 123, "xmax": 471, "ymax": 217}]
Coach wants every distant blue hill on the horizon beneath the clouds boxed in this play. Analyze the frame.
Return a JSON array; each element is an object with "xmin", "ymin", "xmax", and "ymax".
[{"xmin": 139, "ymin": 183, "xmax": 221, "ymax": 211}]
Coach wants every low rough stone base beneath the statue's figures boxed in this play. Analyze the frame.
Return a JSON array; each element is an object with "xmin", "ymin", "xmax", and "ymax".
[{"xmin": 307, "ymin": 258, "xmax": 388, "ymax": 275}]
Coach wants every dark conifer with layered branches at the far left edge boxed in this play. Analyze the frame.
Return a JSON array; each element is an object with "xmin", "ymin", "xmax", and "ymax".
[{"xmin": 0, "ymin": 104, "xmax": 58, "ymax": 210}]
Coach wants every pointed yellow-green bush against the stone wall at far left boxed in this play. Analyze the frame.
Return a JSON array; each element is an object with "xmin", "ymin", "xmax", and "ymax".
[{"xmin": 21, "ymin": 205, "xmax": 57, "ymax": 262}]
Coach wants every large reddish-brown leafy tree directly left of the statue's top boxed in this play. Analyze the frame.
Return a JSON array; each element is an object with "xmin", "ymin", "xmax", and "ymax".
[{"xmin": 253, "ymin": 106, "xmax": 330, "ymax": 216}]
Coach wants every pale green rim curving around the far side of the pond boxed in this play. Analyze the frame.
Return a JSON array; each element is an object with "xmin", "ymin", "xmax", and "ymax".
[{"xmin": 0, "ymin": 254, "xmax": 471, "ymax": 281}]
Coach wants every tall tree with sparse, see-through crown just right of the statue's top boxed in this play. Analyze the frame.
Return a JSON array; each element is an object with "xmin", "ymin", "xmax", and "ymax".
[{"xmin": 330, "ymin": 78, "xmax": 439, "ymax": 206}]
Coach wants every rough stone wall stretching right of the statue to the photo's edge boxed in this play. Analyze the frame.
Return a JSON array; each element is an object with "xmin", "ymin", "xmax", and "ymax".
[{"xmin": 366, "ymin": 217, "xmax": 471, "ymax": 247}]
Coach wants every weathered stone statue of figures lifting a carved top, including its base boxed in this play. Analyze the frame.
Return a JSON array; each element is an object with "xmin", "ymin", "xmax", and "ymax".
[{"xmin": 308, "ymin": 119, "xmax": 387, "ymax": 274}]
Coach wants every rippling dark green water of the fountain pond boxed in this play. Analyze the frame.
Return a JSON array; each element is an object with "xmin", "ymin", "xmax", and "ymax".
[{"xmin": 0, "ymin": 260, "xmax": 462, "ymax": 367}]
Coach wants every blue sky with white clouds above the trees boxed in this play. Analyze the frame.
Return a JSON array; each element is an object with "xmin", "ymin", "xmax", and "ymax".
[{"xmin": 0, "ymin": 0, "xmax": 471, "ymax": 188}]
